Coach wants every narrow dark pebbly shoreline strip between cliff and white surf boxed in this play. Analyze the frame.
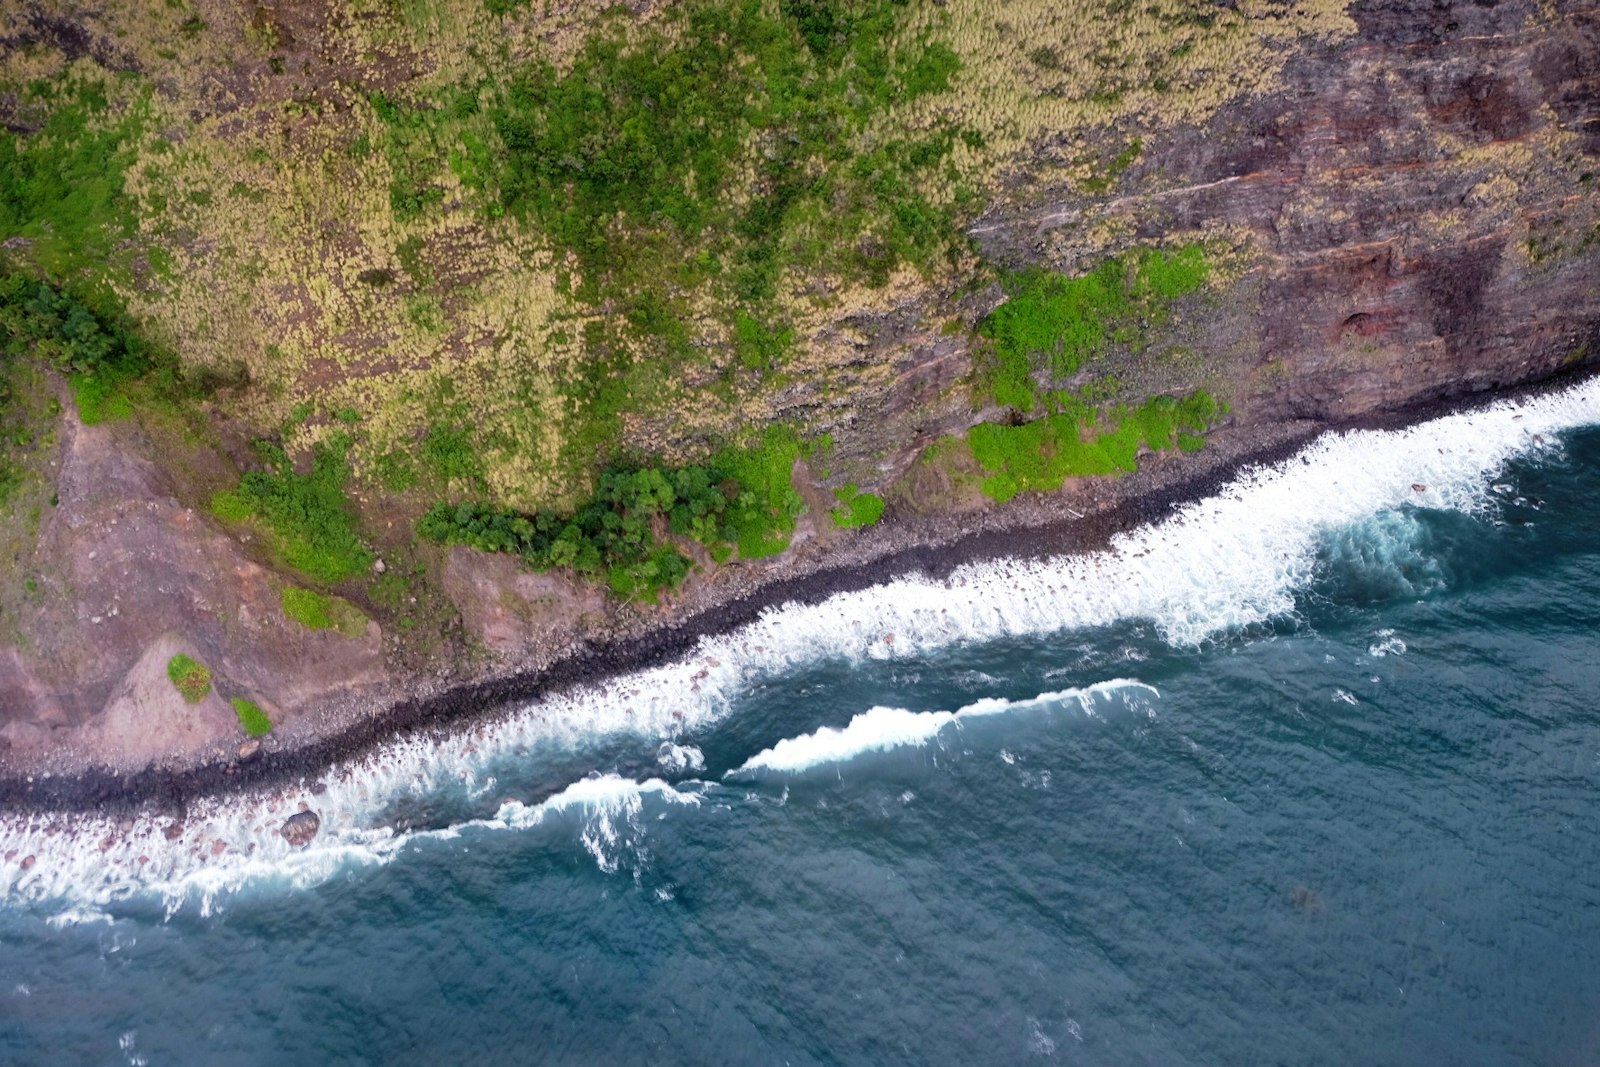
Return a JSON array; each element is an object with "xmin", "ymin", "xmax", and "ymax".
[{"xmin": 0, "ymin": 366, "xmax": 1597, "ymax": 814}]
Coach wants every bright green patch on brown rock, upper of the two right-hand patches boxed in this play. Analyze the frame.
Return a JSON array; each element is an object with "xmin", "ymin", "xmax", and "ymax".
[{"xmin": 978, "ymin": 245, "xmax": 1210, "ymax": 413}]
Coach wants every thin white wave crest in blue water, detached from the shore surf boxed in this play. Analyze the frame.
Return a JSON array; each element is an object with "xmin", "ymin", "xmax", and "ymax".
[{"xmin": 728, "ymin": 678, "xmax": 1160, "ymax": 776}]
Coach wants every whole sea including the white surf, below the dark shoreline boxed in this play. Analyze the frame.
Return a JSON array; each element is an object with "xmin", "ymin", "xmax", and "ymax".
[{"xmin": 0, "ymin": 382, "xmax": 1600, "ymax": 1064}]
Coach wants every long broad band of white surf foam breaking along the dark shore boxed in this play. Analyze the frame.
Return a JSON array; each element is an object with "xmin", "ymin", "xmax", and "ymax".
[{"xmin": 0, "ymin": 379, "xmax": 1600, "ymax": 915}]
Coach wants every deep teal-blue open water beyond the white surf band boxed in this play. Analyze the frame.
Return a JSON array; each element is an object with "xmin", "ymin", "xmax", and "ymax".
[{"xmin": 0, "ymin": 430, "xmax": 1600, "ymax": 1065}]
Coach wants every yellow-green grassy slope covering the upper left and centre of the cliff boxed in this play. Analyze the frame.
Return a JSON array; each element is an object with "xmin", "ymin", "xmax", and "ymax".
[{"xmin": 0, "ymin": 0, "xmax": 1349, "ymax": 601}]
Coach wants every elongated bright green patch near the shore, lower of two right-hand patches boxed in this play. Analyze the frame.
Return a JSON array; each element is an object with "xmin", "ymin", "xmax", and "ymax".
[{"xmin": 966, "ymin": 390, "xmax": 1219, "ymax": 502}]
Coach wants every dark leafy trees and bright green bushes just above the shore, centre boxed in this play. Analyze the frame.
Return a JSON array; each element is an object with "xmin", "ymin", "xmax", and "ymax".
[{"xmin": 418, "ymin": 429, "xmax": 802, "ymax": 600}]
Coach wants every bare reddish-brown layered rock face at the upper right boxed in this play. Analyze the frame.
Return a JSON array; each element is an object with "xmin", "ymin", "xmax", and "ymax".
[{"xmin": 974, "ymin": 0, "xmax": 1600, "ymax": 421}]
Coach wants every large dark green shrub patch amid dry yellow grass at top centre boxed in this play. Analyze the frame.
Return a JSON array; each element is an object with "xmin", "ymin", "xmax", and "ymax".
[{"xmin": 494, "ymin": 0, "xmax": 960, "ymax": 301}]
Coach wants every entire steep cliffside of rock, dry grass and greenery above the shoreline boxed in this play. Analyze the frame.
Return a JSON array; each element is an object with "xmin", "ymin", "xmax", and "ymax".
[{"xmin": 0, "ymin": 0, "xmax": 1600, "ymax": 774}]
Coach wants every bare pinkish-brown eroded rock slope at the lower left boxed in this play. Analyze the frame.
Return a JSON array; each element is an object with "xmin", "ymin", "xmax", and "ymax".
[{"xmin": 0, "ymin": 405, "xmax": 387, "ymax": 771}]
